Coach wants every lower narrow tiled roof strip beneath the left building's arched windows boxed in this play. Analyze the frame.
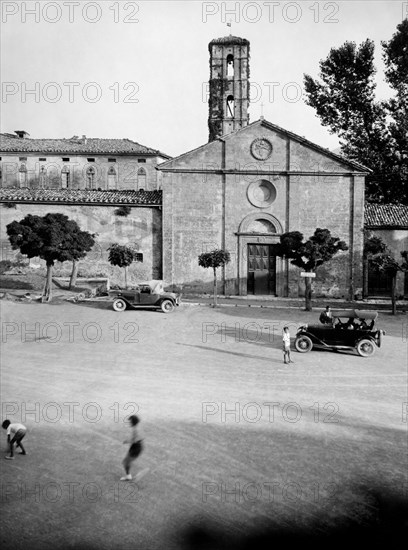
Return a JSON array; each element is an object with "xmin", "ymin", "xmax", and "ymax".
[{"xmin": 0, "ymin": 187, "xmax": 162, "ymax": 206}]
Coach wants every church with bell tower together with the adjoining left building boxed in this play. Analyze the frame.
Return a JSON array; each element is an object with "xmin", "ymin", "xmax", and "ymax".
[{"xmin": 0, "ymin": 36, "xmax": 369, "ymax": 297}]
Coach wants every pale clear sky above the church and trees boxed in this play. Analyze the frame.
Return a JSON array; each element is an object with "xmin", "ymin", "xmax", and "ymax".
[{"xmin": 0, "ymin": 0, "xmax": 408, "ymax": 156}]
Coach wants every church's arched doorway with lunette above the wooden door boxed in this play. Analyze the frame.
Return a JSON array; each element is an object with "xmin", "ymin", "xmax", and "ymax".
[{"xmin": 237, "ymin": 213, "xmax": 283, "ymax": 296}]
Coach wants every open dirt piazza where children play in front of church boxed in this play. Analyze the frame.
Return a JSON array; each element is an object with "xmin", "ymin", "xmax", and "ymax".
[{"xmin": 1, "ymin": 301, "xmax": 408, "ymax": 549}]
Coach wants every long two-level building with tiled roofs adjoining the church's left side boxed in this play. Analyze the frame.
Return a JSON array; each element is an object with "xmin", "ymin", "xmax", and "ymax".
[{"xmin": 0, "ymin": 131, "xmax": 170, "ymax": 279}]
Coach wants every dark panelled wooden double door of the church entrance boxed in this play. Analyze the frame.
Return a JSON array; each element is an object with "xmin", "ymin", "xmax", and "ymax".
[{"xmin": 247, "ymin": 244, "xmax": 277, "ymax": 295}]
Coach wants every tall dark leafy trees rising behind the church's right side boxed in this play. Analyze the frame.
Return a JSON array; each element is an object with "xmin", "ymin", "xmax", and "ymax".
[{"xmin": 304, "ymin": 19, "xmax": 408, "ymax": 204}]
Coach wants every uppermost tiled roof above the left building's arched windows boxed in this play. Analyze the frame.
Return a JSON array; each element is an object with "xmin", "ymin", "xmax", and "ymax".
[{"xmin": 0, "ymin": 134, "xmax": 170, "ymax": 158}]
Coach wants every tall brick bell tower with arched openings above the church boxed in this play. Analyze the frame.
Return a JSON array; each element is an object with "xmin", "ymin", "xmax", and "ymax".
[{"xmin": 208, "ymin": 35, "xmax": 249, "ymax": 141}]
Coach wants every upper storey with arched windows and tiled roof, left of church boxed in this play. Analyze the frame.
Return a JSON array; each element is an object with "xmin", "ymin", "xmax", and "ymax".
[{"xmin": 0, "ymin": 131, "xmax": 170, "ymax": 191}]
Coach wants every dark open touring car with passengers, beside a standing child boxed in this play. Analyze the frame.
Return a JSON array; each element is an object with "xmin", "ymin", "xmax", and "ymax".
[{"xmin": 295, "ymin": 309, "xmax": 385, "ymax": 357}]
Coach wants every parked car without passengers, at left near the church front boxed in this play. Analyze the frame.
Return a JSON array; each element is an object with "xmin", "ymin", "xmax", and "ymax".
[{"xmin": 109, "ymin": 281, "xmax": 181, "ymax": 313}]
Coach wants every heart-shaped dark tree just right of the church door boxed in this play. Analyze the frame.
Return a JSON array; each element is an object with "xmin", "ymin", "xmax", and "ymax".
[{"xmin": 277, "ymin": 228, "xmax": 348, "ymax": 311}]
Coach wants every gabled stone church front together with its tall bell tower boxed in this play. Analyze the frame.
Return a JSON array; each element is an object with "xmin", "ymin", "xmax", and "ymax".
[{"xmin": 158, "ymin": 36, "xmax": 368, "ymax": 297}]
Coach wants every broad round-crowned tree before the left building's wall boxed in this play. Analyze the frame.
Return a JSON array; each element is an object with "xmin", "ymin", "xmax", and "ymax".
[{"xmin": 7, "ymin": 214, "xmax": 95, "ymax": 302}]
